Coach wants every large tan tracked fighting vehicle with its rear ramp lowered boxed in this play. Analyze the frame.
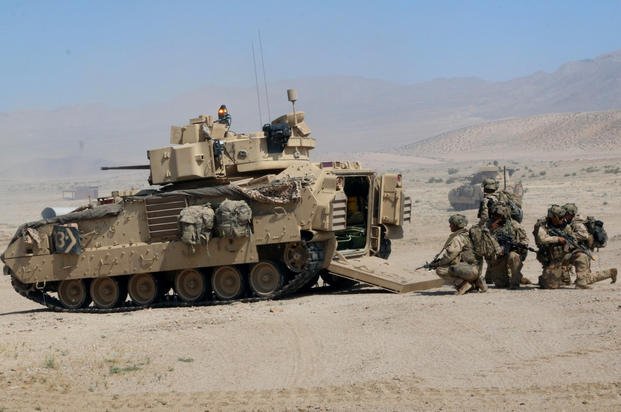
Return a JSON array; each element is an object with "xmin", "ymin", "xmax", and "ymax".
[{"xmin": 1, "ymin": 90, "xmax": 441, "ymax": 311}]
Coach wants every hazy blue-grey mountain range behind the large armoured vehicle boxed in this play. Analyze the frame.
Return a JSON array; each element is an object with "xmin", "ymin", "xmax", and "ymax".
[{"xmin": 0, "ymin": 50, "xmax": 621, "ymax": 176}]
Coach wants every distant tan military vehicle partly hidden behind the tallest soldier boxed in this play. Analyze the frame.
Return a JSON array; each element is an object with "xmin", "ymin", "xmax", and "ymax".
[{"xmin": 448, "ymin": 166, "xmax": 524, "ymax": 210}]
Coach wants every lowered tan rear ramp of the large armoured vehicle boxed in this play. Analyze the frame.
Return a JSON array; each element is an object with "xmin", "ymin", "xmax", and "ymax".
[{"xmin": 328, "ymin": 252, "xmax": 444, "ymax": 293}]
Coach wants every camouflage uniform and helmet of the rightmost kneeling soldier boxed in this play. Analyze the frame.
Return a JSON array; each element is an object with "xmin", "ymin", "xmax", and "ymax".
[{"xmin": 561, "ymin": 203, "xmax": 617, "ymax": 289}]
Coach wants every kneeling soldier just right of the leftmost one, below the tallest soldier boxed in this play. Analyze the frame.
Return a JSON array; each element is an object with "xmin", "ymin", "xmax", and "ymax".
[{"xmin": 485, "ymin": 204, "xmax": 530, "ymax": 289}]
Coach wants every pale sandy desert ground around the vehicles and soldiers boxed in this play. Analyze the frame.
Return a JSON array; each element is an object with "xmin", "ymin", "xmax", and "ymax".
[{"xmin": 0, "ymin": 159, "xmax": 621, "ymax": 411}]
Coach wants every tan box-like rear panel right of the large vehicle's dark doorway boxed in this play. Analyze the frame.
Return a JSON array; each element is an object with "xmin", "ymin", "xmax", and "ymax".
[{"xmin": 373, "ymin": 173, "xmax": 412, "ymax": 226}]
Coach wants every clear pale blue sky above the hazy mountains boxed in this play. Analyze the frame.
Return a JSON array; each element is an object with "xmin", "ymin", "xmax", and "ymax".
[{"xmin": 0, "ymin": 0, "xmax": 621, "ymax": 112}]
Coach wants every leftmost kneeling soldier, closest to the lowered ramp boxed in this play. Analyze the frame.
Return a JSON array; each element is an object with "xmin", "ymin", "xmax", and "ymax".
[{"xmin": 433, "ymin": 214, "xmax": 486, "ymax": 295}]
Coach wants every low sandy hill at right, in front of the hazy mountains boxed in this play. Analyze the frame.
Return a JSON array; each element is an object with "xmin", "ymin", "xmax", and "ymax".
[{"xmin": 399, "ymin": 110, "xmax": 621, "ymax": 159}]
